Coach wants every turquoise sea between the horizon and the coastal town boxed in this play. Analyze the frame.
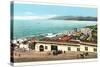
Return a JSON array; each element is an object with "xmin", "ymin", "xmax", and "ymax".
[{"xmin": 11, "ymin": 20, "xmax": 97, "ymax": 39}]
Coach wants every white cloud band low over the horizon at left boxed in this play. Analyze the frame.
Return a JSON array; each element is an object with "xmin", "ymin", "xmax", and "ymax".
[{"xmin": 14, "ymin": 15, "xmax": 56, "ymax": 20}]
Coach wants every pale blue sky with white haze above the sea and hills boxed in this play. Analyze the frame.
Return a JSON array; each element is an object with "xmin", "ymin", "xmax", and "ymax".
[{"xmin": 14, "ymin": 3, "xmax": 97, "ymax": 19}]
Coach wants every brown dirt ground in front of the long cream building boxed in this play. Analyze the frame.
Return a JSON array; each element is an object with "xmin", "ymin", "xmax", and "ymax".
[{"xmin": 12, "ymin": 51, "xmax": 97, "ymax": 63}]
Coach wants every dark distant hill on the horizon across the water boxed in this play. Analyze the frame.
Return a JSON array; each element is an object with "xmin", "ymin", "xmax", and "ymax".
[{"xmin": 49, "ymin": 16, "xmax": 97, "ymax": 21}]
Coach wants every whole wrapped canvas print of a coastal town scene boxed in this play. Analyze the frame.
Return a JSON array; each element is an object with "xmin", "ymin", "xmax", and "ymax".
[{"xmin": 10, "ymin": 1, "xmax": 98, "ymax": 63}]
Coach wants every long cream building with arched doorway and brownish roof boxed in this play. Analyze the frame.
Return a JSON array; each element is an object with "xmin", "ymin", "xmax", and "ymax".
[{"xmin": 35, "ymin": 41, "xmax": 97, "ymax": 53}]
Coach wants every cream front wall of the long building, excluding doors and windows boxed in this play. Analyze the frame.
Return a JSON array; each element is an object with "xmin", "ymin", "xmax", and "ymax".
[{"xmin": 35, "ymin": 43, "xmax": 97, "ymax": 52}]
